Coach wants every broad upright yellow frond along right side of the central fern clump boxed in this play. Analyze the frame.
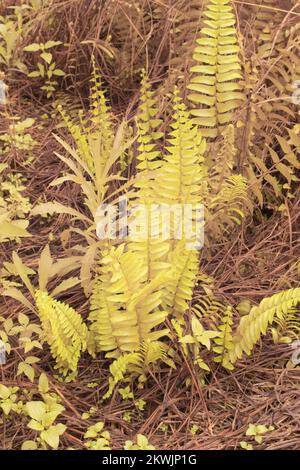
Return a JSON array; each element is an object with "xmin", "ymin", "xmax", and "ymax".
[{"xmin": 151, "ymin": 88, "xmax": 207, "ymax": 318}]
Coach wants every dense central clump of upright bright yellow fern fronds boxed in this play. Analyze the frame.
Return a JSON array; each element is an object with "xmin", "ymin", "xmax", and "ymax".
[{"xmin": 90, "ymin": 82, "xmax": 209, "ymax": 396}]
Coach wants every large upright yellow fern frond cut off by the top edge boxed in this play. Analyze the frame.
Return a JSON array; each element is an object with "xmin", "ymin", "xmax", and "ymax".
[{"xmin": 188, "ymin": 0, "xmax": 244, "ymax": 138}]
